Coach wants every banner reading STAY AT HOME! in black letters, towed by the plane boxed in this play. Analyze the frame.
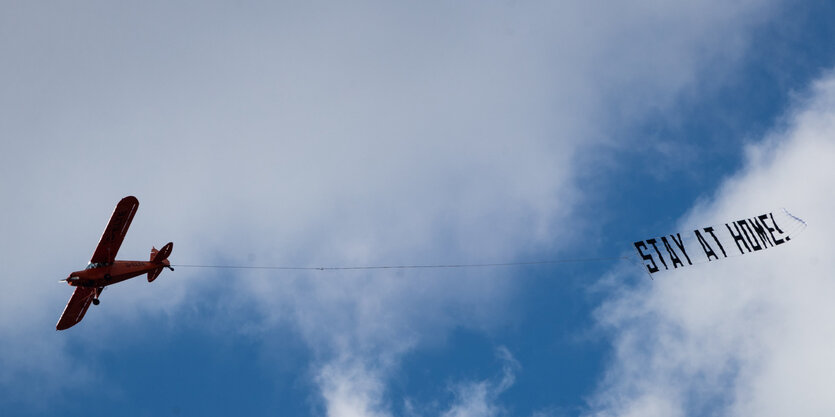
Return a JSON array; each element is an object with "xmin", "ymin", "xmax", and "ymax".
[{"xmin": 634, "ymin": 209, "xmax": 806, "ymax": 274}]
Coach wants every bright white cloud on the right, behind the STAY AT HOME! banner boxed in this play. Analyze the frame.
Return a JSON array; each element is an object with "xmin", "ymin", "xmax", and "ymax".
[{"xmin": 591, "ymin": 73, "xmax": 835, "ymax": 416}]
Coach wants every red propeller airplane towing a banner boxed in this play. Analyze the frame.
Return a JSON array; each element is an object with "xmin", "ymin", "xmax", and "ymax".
[{"xmin": 55, "ymin": 196, "xmax": 174, "ymax": 330}]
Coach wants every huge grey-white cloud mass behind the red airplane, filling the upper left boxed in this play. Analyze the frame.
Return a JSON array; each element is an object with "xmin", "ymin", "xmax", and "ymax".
[{"xmin": 0, "ymin": 1, "xmax": 792, "ymax": 415}]
